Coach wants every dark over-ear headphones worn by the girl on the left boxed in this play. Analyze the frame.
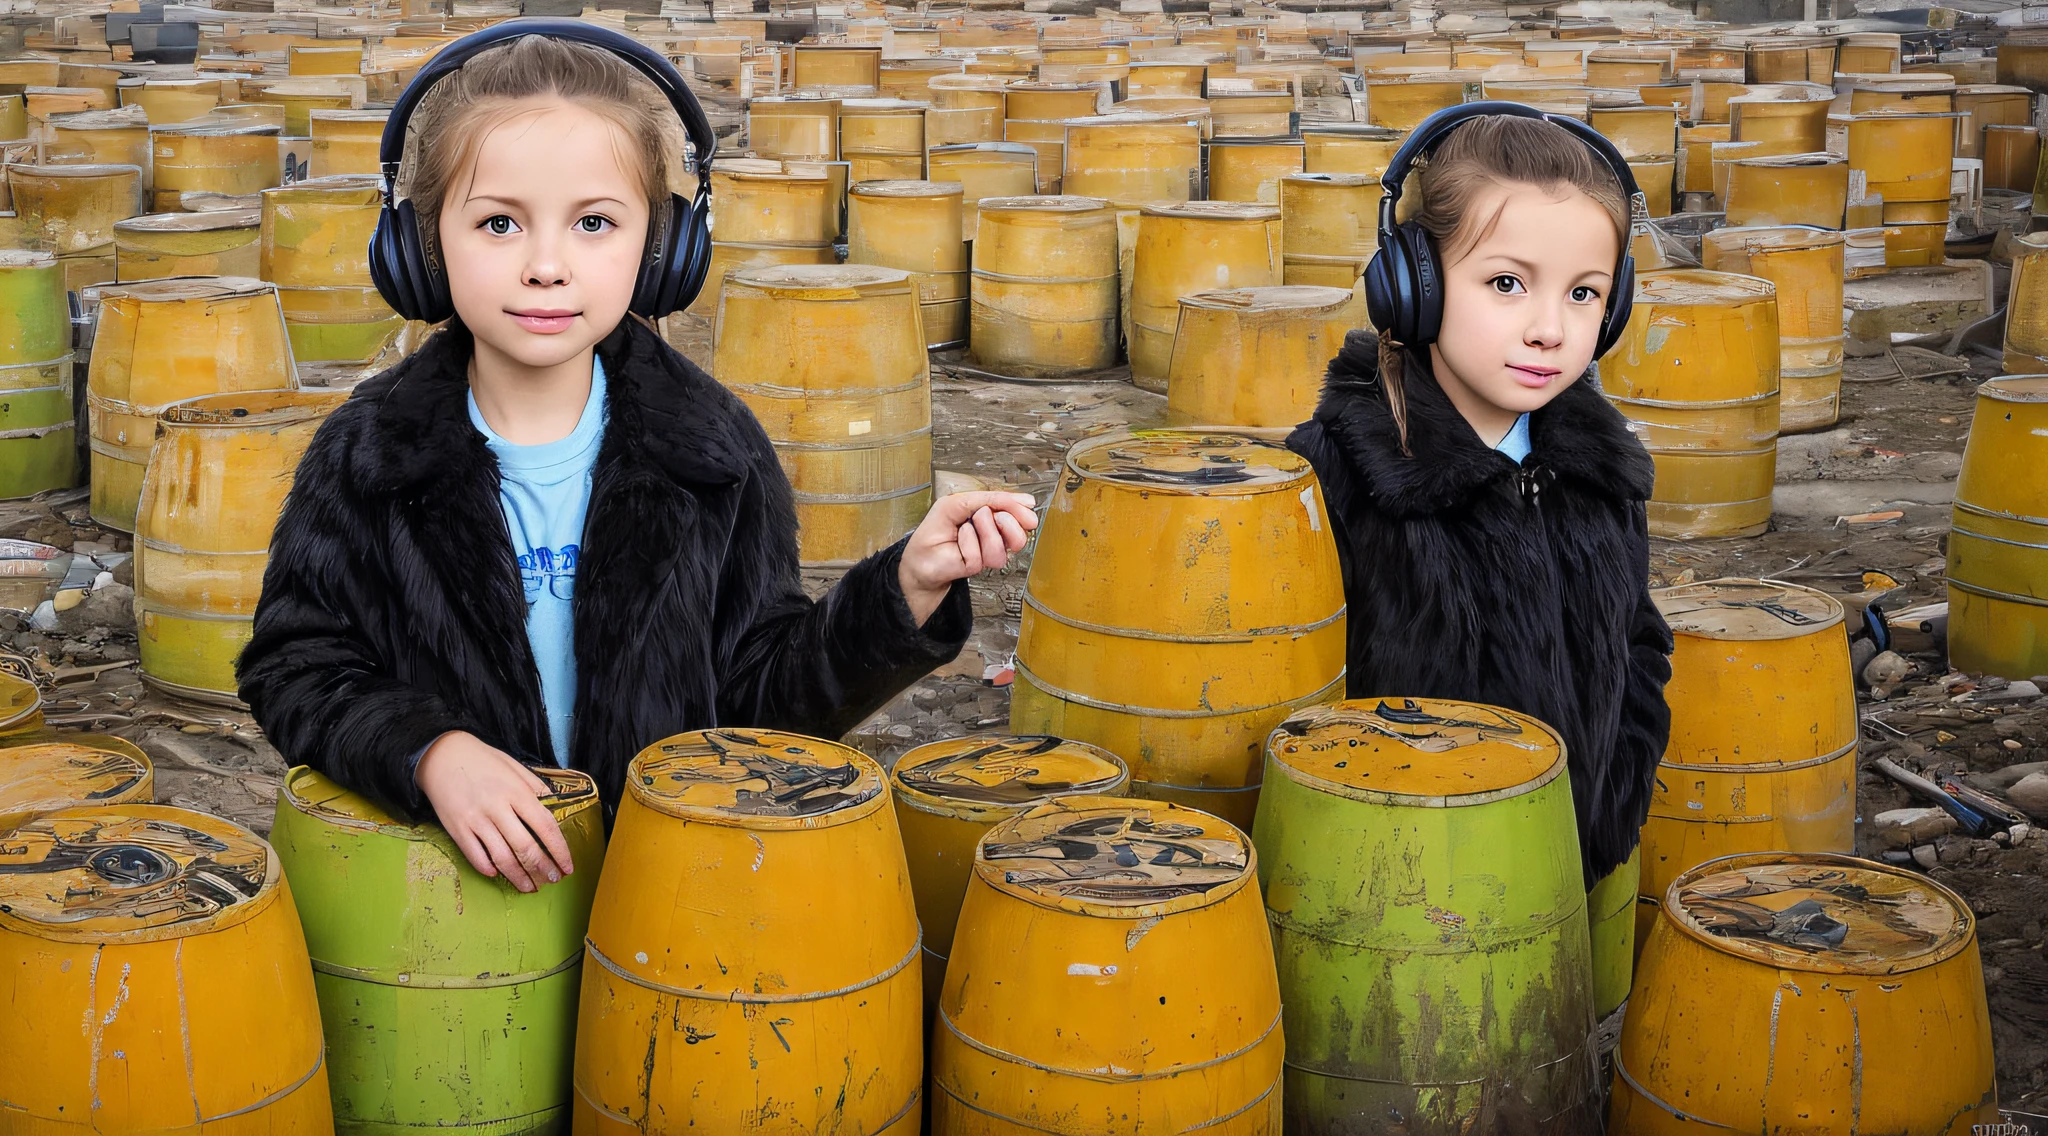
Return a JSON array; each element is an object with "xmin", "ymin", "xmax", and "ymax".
[{"xmin": 371, "ymin": 18, "xmax": 717, "ymax": 323}]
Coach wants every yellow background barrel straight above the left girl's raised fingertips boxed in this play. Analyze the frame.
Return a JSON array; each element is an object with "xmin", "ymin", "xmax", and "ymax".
[{"xmin": 969, "ymin": 196, "xmax": 1118, "ymax": 379}]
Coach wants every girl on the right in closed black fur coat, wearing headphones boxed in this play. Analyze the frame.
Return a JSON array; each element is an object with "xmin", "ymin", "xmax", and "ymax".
[{"xmin": 1288, "ymin": 102, "xmax": 1671, "ymax": 908}]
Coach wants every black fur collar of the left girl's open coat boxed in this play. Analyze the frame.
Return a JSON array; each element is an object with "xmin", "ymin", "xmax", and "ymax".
[{"xmin": 348, "ymin": 315, "xmax": 754, "ymax": 497}]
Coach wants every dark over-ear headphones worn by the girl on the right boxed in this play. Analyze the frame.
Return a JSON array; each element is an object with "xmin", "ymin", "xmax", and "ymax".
[{"xmin": 1366, "ymin": 102, "xmax": 1642, "ymax": 358}]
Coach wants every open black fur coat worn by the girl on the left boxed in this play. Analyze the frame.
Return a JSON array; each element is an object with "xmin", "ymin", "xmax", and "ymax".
[{"xmin": 240, "ymin": 317, "xmax": 973, "ymax": 817}]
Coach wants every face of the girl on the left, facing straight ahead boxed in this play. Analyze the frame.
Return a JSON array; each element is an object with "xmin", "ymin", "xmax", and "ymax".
[{"xmin": 438, "ymin": 98, "xmax": 647, "ymax": 368}]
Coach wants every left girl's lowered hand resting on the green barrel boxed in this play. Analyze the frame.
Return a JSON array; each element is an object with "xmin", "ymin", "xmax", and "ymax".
[{"xmin": 412, "ymin": 733, "xmax": 575, "ymax": 892}]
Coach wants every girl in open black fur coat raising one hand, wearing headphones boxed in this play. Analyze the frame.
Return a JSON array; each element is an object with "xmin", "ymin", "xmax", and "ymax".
[{"xmin": 240, "ymin": 20, "xmax": 1036, "ymax": 890}]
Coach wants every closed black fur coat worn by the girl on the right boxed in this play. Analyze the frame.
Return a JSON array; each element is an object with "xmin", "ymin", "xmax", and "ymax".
[{"xmin": 1288, "ymin": 332, "xmax": 1671, "ymax": 886}]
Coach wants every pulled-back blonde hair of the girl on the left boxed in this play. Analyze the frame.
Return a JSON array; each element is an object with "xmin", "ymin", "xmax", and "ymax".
[{"xmin": 395, "ymin": 35, "xmax": 682, "ymax": 258}]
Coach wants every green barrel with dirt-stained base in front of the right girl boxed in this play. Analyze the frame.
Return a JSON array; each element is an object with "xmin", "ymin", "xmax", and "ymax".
[{"xmin": 1253, "ymin": 698, "xmax": 1599, "ymax": 1136}]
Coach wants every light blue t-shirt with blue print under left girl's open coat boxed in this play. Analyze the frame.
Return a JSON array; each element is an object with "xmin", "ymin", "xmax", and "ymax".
[{"xmin": 469, "ymin": 356, "xmax": 604, "ymax": 766}]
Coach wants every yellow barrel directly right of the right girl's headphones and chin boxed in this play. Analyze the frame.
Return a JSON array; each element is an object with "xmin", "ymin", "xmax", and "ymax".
[{"xmin": 1599, "ymin": 268, "xmax": 1780, "ymax": 540}]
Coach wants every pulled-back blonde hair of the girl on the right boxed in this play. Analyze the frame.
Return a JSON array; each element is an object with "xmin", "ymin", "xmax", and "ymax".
[{"xmin": 1380, "ymin": 115, "xmax": 1628, "ymax": 454}]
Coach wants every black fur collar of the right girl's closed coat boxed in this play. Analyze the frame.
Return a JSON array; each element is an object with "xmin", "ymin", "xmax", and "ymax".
[{"xmin": 1315, "ymin": 332, "xmax": 1655, "ymax": 516}]
